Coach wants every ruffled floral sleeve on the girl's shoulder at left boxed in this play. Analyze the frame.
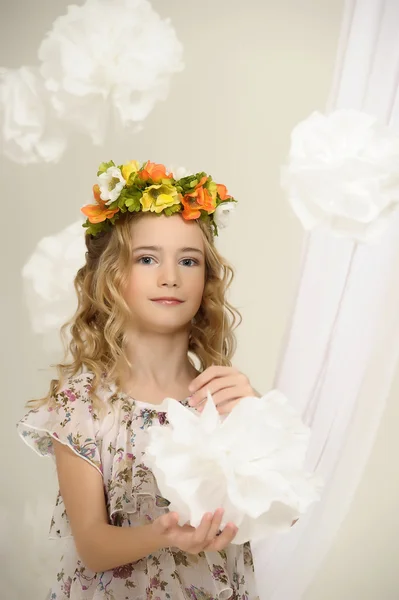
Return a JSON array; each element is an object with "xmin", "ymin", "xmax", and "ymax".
[{"xmin": 17, "ymin": 374, "xmax": 103, "ymax": 474}]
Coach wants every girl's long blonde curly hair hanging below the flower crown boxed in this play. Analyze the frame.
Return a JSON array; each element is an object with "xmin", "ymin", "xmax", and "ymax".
[{"xmin": 29, "ymin": 213, "xmax": 241, "ymax": 408}]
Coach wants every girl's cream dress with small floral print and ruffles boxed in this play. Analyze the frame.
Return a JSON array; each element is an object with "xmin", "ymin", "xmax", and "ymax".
[{"xmin": 17, "ymin": 373, "xmax": 259, "ymax": 600}]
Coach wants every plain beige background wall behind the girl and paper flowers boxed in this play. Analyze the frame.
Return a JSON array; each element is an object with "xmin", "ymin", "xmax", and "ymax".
[{"xmin": 0, "ymin": 0, "xmax": 399, "ymax": 600}]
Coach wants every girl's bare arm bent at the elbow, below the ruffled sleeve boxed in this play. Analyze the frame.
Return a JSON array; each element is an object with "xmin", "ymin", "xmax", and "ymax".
[{"xmin": 54, "ymin": 441, "xmax": 164, "ymax": 572}]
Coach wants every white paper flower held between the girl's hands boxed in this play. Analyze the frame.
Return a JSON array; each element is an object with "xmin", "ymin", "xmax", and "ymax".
[{"xmin": 144, "ymin": 390, "xmax": 320, "ymax": 544}]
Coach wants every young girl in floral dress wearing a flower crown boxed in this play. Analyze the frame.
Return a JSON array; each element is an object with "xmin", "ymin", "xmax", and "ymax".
[{"xmin": 18, "ymin": 161, "xmax": 258, "ymax": 600}]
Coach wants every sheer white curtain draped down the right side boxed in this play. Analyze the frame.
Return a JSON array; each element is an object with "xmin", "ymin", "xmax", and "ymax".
[{"xmin": 254, "ymin": 0, "xmax": 399, "ymax": 600}]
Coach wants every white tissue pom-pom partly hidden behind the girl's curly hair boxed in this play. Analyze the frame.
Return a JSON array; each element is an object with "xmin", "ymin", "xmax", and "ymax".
[{"xmin": 22, "ymin": 221, "xmax": 86, "ymax": 350}]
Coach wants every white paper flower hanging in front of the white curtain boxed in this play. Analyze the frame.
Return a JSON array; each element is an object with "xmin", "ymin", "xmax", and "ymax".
[{"xmin": 281, "ymin": 110, "xmax": 399, "ymax": 242}]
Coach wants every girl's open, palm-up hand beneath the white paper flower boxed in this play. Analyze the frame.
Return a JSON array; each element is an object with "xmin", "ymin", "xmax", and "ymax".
[{"xmin": 152, "ymin": 509, "xmax": 238, "ymax": 554}]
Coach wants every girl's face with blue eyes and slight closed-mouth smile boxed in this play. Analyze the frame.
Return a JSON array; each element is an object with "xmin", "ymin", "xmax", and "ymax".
[{"xmin": 124, "ymin": 215, "xmax": 205, "ymax": 333}]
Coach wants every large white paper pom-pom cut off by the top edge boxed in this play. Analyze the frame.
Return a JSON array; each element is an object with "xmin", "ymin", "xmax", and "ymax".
[{"xmin": 39, "ymin": 0, "xmax": 183, "ymax": 143}]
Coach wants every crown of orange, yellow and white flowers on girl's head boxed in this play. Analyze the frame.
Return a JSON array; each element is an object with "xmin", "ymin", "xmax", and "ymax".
[{"xmin": 81, "ymin": 160, "xmax": 236, "ymax": 236}]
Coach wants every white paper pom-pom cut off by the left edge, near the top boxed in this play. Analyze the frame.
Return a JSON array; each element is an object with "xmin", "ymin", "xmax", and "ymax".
[{"xmin": 0, "ymin": 67, "xmax": 66, "ymax": 164}]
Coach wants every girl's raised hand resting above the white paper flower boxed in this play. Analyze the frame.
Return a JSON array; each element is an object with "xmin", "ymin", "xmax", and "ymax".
[{"xmin": 189, "ymin": 366, "xmax": 260, "ymax": 415}]
